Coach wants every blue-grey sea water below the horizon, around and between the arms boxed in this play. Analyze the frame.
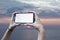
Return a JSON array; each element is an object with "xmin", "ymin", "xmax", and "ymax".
[{"xmin": 0, "ymin": 24, "xmax": 60, "ymax": 40}]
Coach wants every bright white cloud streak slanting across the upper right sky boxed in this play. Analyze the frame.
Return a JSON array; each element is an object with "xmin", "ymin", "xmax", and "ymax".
[{"xmin": 18, "ymin": 0, "xmax": 60, "ymax": 8}]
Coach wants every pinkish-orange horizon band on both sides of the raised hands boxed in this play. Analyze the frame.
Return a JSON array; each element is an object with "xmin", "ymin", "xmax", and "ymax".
[{"xmin": 0, "ymin": 17, "xmax": 60, "ymax": 25}]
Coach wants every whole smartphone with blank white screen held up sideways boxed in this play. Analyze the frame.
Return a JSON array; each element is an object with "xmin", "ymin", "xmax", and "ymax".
[{"xmin": 13, "ymin": 12, "xmax": 35, "ymax": 24}]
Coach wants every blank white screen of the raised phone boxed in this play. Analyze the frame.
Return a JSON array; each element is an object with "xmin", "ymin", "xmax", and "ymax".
[{"xmin": 15, "ymin": 13, "xmax": 33, "ymax": 23}]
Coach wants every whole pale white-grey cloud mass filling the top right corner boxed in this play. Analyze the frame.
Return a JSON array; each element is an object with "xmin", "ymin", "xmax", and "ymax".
[{"xmin": 16, "ymin": 0, "xmax": 60, "ymax": 8}]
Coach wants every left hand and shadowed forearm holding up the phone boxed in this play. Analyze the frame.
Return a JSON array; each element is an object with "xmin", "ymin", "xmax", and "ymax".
[{"xmin": 1, "ymin": 14, "xmax": 20, "ymax": 40}]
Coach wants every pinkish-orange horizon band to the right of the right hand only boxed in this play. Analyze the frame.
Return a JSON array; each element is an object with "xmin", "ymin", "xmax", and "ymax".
[{"xmin": 40, "ymin": 18, "xmax": 60, "ymax": 25}]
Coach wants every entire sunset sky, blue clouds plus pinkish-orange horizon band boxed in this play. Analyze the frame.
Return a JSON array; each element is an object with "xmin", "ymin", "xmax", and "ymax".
[{"xmin": 0, "ymin": 0, "xmax": 60, "ymax": 25}]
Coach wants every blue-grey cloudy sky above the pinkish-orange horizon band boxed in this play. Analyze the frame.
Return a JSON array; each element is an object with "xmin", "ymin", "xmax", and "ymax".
[{"xmin": 0, "ymin": 0, "xmax": 60, "ymax": 18}]
